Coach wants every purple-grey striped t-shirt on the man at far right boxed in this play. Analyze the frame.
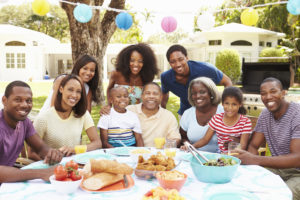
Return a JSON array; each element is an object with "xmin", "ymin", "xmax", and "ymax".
[{"xmin": 254, "ymin": 102, "xmax": 300, "ymax": 156}]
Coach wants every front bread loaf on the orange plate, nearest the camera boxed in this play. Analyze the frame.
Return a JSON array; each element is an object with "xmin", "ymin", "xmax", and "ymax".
[{"xmin": 83, "ymin": 172, "xmax": 123, "ymax": 190}]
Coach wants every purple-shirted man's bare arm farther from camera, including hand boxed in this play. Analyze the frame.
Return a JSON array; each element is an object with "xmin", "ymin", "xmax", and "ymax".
[{"xmin": 26, "ymin": 134, "xmax": 63, "ymax": 165}]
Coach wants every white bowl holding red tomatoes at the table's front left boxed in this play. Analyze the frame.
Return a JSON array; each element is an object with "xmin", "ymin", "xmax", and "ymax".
[{"xmin": 49, "ymin": 175, "xmax": 82, "ymax": 194}]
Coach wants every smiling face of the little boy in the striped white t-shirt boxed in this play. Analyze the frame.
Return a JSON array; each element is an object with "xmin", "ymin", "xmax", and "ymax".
[{"xmin": 110, "ymin": 87, "xmax": 129, "ymax": 112}]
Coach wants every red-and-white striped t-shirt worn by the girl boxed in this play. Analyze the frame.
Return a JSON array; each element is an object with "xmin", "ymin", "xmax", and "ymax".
[{"xmin": 208, "ymin": 113, "xmax": 252, "ymax": 152}]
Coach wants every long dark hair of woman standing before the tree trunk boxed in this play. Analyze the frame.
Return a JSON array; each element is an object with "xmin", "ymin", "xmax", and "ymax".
[{"xmin": 71, "ymin": 55, "xmax": 99, "ymax": 102}]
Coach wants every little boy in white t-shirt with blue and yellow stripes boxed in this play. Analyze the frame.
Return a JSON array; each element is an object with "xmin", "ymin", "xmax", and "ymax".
[{"xmin": 98, "ymin": 86, "xmax": 144, "ymax": 148}]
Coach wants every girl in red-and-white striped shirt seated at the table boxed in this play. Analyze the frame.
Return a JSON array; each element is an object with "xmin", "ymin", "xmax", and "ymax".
[{"xmin": 193, "ymin": 87, "xmax": 251, "ymax": 153}]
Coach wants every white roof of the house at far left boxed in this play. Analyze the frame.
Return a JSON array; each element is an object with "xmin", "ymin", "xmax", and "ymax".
[{"xmin": 0, "ymin": 24, "xmax": 60, "ymax": 44}]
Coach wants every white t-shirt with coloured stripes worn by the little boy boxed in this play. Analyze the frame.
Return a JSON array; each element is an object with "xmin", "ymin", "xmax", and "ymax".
[{"xmin": 97, "ymin": 108, "xmax": 142, "ymax": 147}]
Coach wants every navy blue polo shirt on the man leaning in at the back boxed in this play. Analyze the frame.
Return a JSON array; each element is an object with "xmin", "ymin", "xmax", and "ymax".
[{"xmin": 160, "ymin": 60, "xmax": 223, "ymax": 115}]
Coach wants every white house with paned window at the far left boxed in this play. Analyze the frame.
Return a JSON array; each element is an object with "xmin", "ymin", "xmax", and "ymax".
[{"xmin": 0, "ymin": 24, "xmax": 60, "ymax": 81}]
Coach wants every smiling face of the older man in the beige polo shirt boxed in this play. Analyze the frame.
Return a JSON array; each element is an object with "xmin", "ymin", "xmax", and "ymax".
[{"xmin": 142, "ymin": 84, "xmax": 162, "ymax": 110}]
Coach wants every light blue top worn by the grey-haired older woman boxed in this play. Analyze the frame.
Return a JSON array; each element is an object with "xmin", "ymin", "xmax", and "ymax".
[{"xmin": 180, "ymin": 104, "xmax": 224, "ymax": 153}]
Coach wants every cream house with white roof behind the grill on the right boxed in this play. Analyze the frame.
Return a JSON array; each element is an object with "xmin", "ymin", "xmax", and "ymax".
[{"xmin": 184, "ymin": 23, "xmax": 285, "ymax": 64}]
